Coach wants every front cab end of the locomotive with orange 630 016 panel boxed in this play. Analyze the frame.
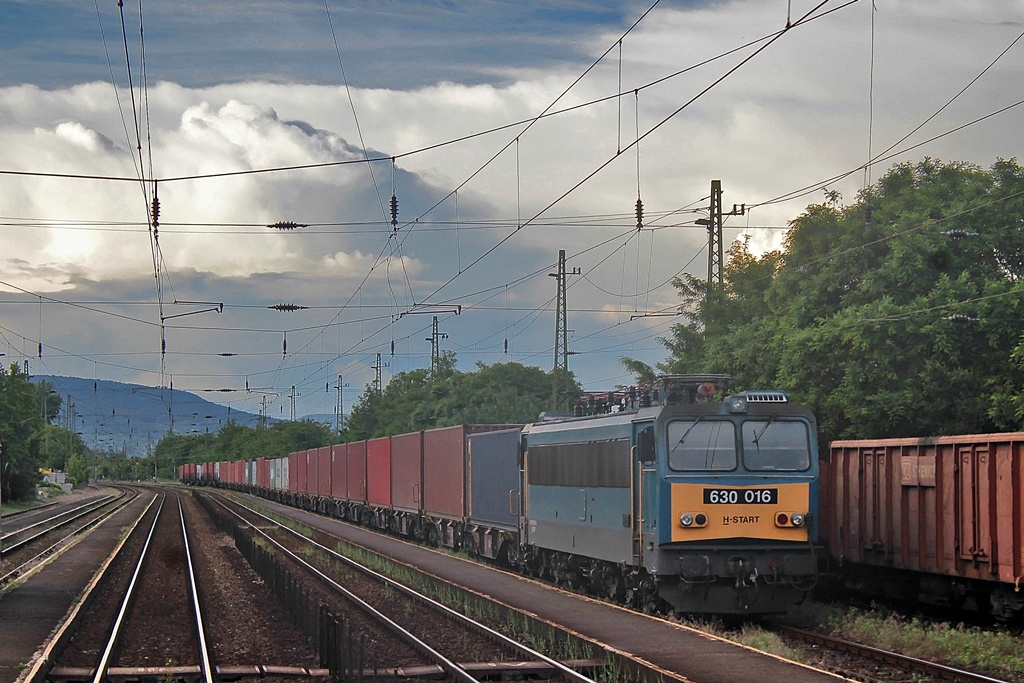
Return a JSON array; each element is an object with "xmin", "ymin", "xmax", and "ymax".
[{"xmin": 639, "ymin": 391, "xmax": 819, "ymax": 613}]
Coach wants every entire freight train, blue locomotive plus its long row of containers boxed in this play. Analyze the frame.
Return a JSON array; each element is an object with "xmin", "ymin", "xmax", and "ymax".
[{"xmin": 179, "ymin": 375, "xmax": 820, "ymax": 614}]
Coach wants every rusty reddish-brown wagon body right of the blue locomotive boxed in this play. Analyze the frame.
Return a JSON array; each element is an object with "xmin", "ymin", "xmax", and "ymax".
[{"xmin": 821, "ymin": 432, "xmax": 1024, "ymax": 583}]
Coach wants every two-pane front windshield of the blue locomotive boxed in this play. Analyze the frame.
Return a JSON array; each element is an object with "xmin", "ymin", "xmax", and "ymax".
[{"xmin": 668, "ymin": 418, "xmax": 811, "ymax": 472}]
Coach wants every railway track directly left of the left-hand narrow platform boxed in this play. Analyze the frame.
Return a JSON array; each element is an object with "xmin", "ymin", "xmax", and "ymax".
[{"xmin": 0, "ymin": 488, "xmax": 135, "ymax": 588}]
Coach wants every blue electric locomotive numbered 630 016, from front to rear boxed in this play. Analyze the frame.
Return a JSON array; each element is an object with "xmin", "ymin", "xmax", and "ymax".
[{"xmin": 510, "ymin": 375, "xmax": 818, "ymax": 614}]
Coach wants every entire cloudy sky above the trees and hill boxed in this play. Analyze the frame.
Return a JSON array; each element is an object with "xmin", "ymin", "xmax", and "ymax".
[{"xmin": 0, "ymin": 0, "xmax": 1024, "ymax": 428}]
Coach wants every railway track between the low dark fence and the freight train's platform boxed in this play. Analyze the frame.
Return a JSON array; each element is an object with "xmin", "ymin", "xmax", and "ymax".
[{"xmin": 209, "ymin": 491, "xmax": 601, "ymax": 683}]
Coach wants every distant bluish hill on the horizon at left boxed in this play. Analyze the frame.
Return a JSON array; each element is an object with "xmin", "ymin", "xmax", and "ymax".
[{"xmin": 32, "ymin": 375, "xmax": 278, "ymax": 457}]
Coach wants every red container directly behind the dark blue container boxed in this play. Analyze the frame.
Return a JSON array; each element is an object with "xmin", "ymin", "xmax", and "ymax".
[{"xmin": 423, "ymin": 425, "xmax": 522, "ymax": 519}]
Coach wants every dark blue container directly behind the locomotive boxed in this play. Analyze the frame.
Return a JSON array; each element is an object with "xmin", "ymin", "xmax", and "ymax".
[{"xmin": 466, "ymin": 429, "xmax": 522, "ymax": 530}]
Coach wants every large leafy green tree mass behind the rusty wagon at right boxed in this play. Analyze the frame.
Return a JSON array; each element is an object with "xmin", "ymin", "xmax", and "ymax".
[{"xmin": 628, "ymin": 159, "xmax": 1024, "ymax": 438}]
